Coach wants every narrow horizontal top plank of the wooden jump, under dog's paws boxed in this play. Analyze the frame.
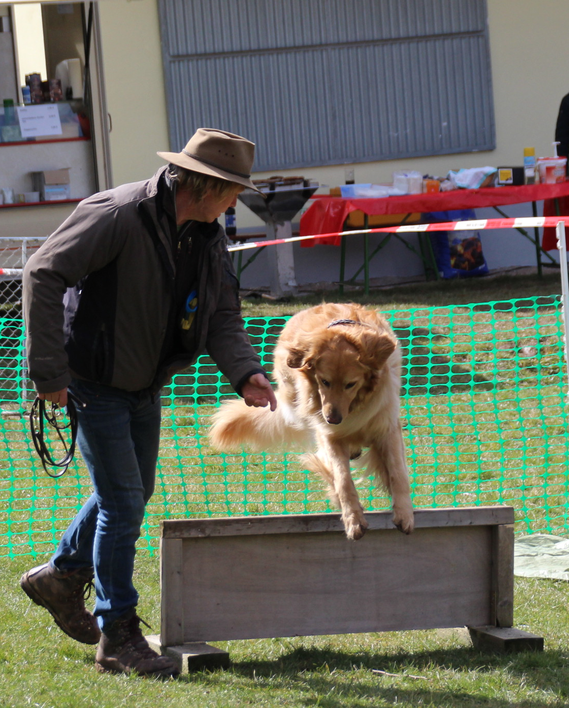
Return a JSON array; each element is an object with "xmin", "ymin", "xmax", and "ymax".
[{"xmin": 160, "ymin": 506, "xmax": 514, "ymax": 538}]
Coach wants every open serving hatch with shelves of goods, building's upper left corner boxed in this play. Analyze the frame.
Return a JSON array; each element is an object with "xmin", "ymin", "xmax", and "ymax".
[{"xmin": 0, "ymin": 0, "xmax": 110, "ymax": 206}]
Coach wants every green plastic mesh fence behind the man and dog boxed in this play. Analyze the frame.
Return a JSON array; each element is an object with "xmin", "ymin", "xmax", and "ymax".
[{"xmin": 0, "ymin": 296, "xmax": 568, "ymax": 556}]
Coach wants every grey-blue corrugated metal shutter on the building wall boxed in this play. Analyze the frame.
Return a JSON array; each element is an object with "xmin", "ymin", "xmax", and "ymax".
[{"xmin": 159, "ymin": 0, "xmax": 495, "ymax": 171}]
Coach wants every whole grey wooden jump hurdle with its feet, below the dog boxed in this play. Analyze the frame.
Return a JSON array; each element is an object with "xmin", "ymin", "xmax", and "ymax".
[{"xmin": 148, "ymin": 506, "xmax": 543, "ymax": 671}]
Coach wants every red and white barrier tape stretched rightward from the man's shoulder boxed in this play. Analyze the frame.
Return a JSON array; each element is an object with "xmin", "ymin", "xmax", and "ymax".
[{"xmin": 228, "ymin": 216, "xmax": 569, "ymax": 252}]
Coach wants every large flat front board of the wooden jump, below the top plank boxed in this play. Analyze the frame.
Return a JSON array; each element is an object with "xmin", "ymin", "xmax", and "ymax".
[{"xmin": 162, "ymin": 526, "xmax": 493, "ymax": 645}]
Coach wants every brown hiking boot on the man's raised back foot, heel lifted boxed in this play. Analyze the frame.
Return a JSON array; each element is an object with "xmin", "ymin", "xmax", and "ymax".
[{"xmin": 20, "ymin": 563, "xmax": 101, "ymax": 644}]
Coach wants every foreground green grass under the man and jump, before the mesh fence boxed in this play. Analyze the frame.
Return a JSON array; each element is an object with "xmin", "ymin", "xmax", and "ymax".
[{"xmin": 0, "ymin": 556, "xmax": 569, "ymax": 708}]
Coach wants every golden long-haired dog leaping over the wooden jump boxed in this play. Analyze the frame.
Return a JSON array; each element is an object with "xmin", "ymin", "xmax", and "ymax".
[{"xmin": 210, "ymin": 303, "xmax": 414, "ymax": 540}]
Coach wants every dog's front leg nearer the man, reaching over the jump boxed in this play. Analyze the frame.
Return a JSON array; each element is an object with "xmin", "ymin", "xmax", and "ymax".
[{"xmin": 316, "ymin": 439, "xmax": 368, "ymax": 541}]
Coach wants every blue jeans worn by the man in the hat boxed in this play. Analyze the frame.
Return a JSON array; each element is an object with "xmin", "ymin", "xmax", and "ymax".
[{"xmin": 51, "ymin": 380, "xmax": 160, "ymax": 629}]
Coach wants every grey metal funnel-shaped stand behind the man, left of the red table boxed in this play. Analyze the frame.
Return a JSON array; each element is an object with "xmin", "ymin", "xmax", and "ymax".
[{"xmin": 239, "ymin": 177, "xmax": 319, "ymax": 298}]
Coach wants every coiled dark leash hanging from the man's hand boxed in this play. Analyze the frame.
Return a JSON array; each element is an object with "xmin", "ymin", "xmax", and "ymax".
[{"xmin": 30, "ymin": 392, "xmax": 85, "ymax": 479}]
